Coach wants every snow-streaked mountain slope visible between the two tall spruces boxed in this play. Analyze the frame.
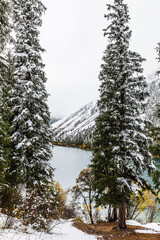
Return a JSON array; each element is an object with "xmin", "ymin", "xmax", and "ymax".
[{"xmin": 52, "ymin": 102, "xmax": 98, "ymax": 145}]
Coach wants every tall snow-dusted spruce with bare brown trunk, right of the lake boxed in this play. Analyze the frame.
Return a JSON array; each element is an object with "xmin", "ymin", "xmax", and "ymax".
[{"xmin": 91, "ymin": 0, "xmax": 154, "ymax": 228}]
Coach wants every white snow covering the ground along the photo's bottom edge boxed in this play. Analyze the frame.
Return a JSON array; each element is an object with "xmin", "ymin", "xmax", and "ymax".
[{"xmin": 0, "ymin": 215, "xmax": 160, "ymax": 240}]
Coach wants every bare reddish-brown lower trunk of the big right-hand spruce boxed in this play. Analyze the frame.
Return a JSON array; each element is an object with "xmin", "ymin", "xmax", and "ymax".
[{"xmin": 118, "ymin": 193, "xmax": 127, "ymax": 229}]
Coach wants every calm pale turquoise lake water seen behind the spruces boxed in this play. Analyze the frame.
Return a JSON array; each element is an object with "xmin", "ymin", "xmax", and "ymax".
[{"xmin": 51, "ymin": 146, "xmax": 160, "ymax": 189}]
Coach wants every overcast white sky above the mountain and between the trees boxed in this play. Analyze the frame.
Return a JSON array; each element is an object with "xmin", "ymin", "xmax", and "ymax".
[{"xmin": 41, "ymin": 0, "xmax": 160, "ymax": 117}]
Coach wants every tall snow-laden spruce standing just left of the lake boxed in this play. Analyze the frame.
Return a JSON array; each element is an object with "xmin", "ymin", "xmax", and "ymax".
[{"xmin": 10, "ymin": 0, "xmax": 53, "ymax": 227}]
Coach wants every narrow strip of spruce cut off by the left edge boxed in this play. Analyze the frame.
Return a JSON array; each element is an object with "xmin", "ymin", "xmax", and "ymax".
[{"xmin": 0, "ymin": 0, "xmax": 10, "ymax": 200}]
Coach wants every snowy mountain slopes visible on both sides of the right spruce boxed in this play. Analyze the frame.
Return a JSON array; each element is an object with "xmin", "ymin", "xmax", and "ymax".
[{"xmin": 52, "ymin": 78, "xmax": 160, "ymax": 147}]
